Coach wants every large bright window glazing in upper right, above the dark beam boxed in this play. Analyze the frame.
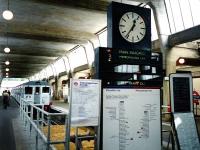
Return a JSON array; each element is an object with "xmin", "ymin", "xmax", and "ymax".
[{"xmin": 165, "ymin": 0, "xmax": 200, "ymax": 33}]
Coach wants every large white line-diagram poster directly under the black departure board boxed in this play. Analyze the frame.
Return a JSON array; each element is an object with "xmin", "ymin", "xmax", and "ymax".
[{"xmin": 103, "ymin": 88, "xmax": 161, "ymax": 150}]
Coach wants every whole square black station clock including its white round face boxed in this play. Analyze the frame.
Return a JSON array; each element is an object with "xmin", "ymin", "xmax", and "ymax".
[{"xmin": 107, "ymin": 2, "xmax": 151, "ymax": 51}]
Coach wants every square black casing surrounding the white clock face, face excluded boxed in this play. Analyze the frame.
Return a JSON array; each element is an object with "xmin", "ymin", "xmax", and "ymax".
[{"xmin": 107, "ymin": 2, "xmax": 151, "ymax": 51}]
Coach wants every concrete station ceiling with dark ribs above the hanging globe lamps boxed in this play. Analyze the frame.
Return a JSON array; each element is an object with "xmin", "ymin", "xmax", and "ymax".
[{"xmin": 0, "ymin": 0, "xmax": 147, "ymax": 78}]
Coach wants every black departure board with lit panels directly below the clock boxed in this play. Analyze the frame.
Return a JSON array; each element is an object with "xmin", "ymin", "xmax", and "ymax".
[{"xmin": 94, "ymin": 47, "xmax": 163, "ymax": 87}]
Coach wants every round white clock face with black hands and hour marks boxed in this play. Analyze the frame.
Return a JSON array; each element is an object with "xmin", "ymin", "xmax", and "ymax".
[{"xmin": 119, "ymin": 12, "xmax": 146, "ymax": 43}]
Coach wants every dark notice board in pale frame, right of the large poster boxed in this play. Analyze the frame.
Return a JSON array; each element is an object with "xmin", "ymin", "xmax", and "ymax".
[{"xmin": 170, "ymin": 73, "xmax": 193, "ymax": 113}]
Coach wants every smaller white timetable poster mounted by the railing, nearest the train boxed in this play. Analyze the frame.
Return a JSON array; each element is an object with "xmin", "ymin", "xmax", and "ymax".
[{"xmin": 70, "ymin": 79, "xmax": 101, "ymax": 127}]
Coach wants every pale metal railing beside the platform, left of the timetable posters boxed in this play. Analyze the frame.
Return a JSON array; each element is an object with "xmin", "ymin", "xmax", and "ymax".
[{"xmin": 20, "ymin": 98, "xmax": 69, "ymax": 150}]
